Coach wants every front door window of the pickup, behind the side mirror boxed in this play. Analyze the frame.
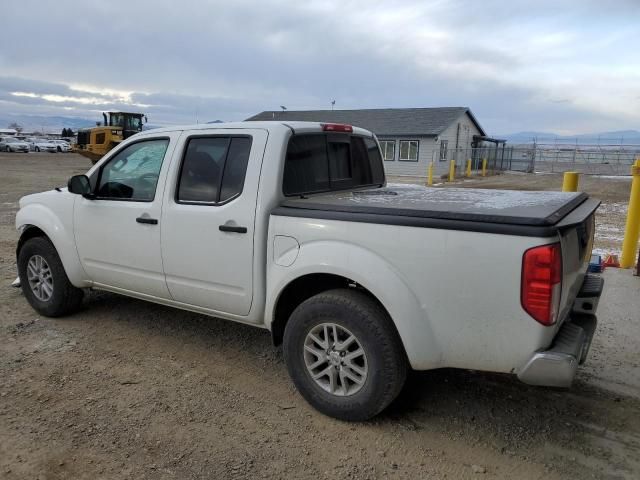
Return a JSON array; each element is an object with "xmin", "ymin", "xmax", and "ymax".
[{"xmin": 96, "ymin": 138, "xmax": 169, "ymax": 202}]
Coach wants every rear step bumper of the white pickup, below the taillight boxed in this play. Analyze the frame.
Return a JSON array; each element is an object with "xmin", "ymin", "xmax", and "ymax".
[{"xmin": 518, "ymin": 275, "xmax": 604, "ymax": 387}]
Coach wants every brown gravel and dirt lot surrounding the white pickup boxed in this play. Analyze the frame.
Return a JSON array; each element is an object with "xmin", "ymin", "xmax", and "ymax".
[{"xmin": 0, "ymin": 154, "xmax": 640, "ymax": 479}]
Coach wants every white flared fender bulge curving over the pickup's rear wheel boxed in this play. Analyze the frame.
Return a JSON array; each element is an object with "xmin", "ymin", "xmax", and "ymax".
[{"xmin": 265, "ymin": 240, "xmax": 442, "ymax": 370}]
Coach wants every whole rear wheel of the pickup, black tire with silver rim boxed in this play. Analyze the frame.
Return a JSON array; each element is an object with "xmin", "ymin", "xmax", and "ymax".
[{"xmin": 283, "ymin": 289, "xmax": 407, "ymax": 421}]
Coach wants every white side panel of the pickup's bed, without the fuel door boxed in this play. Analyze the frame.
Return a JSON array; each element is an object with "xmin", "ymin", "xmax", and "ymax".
[{"xmin": 267, "ymin": 216, "xmax": 557, "ymax": 372}]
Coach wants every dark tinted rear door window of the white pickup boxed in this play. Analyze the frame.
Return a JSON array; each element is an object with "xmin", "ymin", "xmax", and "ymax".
[{"xmin": 176, "ymin": 137, "xmax": 251, "ymax": 205}]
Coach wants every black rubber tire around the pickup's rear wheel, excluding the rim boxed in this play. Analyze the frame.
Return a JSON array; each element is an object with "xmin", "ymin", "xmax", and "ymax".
[{"xmin": 283, "ymin": 289, "xmax": 408, "ymax": 421}]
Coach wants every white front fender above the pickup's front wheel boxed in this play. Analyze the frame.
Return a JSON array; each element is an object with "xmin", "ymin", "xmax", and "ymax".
[{"xmin": 16, "ymin": 193, "xmax": 91, "ymax": 288}]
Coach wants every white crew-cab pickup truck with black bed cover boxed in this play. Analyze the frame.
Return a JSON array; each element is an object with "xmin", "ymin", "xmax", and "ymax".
[{"xmin": 16, "ymin": 122, "xmax": 602, "ymax": 420}]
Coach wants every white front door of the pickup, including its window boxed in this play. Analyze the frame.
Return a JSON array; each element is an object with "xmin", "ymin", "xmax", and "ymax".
[{"xmin": 74, "ymin": 132, "xmax": 179, "ymax": 298}]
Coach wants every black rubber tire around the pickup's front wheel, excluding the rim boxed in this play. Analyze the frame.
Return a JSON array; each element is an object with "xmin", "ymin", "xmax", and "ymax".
[{"xmin": 18, "ymin": 237, "xmax": 84, "ymax": 317}]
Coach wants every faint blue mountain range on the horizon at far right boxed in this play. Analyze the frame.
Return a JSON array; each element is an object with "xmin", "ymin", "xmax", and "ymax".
[{"xmin": 495, "ymin": 130, "xmax": 640, "ymax": 145}]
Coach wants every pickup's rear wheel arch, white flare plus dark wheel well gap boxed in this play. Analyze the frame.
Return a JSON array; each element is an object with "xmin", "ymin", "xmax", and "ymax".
[{"xmin": 265, "ymin": 241, "xmax": 442, "ymax": 370}]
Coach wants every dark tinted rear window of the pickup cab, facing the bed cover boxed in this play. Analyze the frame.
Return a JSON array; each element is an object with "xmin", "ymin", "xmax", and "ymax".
[{"xmin": 282, "ymin": 133, "xmax": 384, "ymax": 195}]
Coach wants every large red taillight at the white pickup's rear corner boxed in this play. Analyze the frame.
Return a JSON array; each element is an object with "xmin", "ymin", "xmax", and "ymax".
[{"xmin": 521, "ymin": 243, "xmax": 562, "ymax": 325}]
